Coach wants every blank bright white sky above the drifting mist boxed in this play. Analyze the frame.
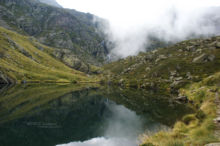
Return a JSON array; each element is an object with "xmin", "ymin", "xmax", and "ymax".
[{"xmin": 57, "ymin": 0, "xmax": 220, "ymax": 25}]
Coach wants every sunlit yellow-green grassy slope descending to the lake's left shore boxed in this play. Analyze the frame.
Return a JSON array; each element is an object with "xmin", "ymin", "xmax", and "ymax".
[{"xmin": 0, "ymin": 27, "xmax": 97, "ymax": 83}]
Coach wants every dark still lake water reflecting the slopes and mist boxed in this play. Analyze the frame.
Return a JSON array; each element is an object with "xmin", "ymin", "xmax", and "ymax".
[{"xmin": 0, "ymin": 84, "xmax": 192, "ymax": 146}]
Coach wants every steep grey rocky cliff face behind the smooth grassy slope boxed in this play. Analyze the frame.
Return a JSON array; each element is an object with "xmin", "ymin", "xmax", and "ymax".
[{"xmin": 0, "ymin": 0, "xmax": 108, "ymax": 64}]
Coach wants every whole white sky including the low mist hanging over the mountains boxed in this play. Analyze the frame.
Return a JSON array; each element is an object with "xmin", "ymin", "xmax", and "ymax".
[{"xmin": 57, "ymin": 0, "xmax": 220, "ymax": 57}]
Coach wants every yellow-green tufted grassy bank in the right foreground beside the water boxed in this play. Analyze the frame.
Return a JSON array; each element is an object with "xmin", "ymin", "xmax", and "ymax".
[{"xmin": 141, "ymin": 72, "xmax": 220, "ymax": 146}]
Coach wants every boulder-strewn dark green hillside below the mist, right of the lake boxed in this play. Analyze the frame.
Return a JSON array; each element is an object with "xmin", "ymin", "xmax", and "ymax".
[{"xmin": 104, "ymin": 37, "xmax": 220, "ymax": 92}]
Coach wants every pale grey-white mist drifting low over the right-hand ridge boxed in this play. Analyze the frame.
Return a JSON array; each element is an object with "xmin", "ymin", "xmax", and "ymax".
[{"xmin": 102, "ymin": 5, "xmax": 220, "ymax": 58}]
